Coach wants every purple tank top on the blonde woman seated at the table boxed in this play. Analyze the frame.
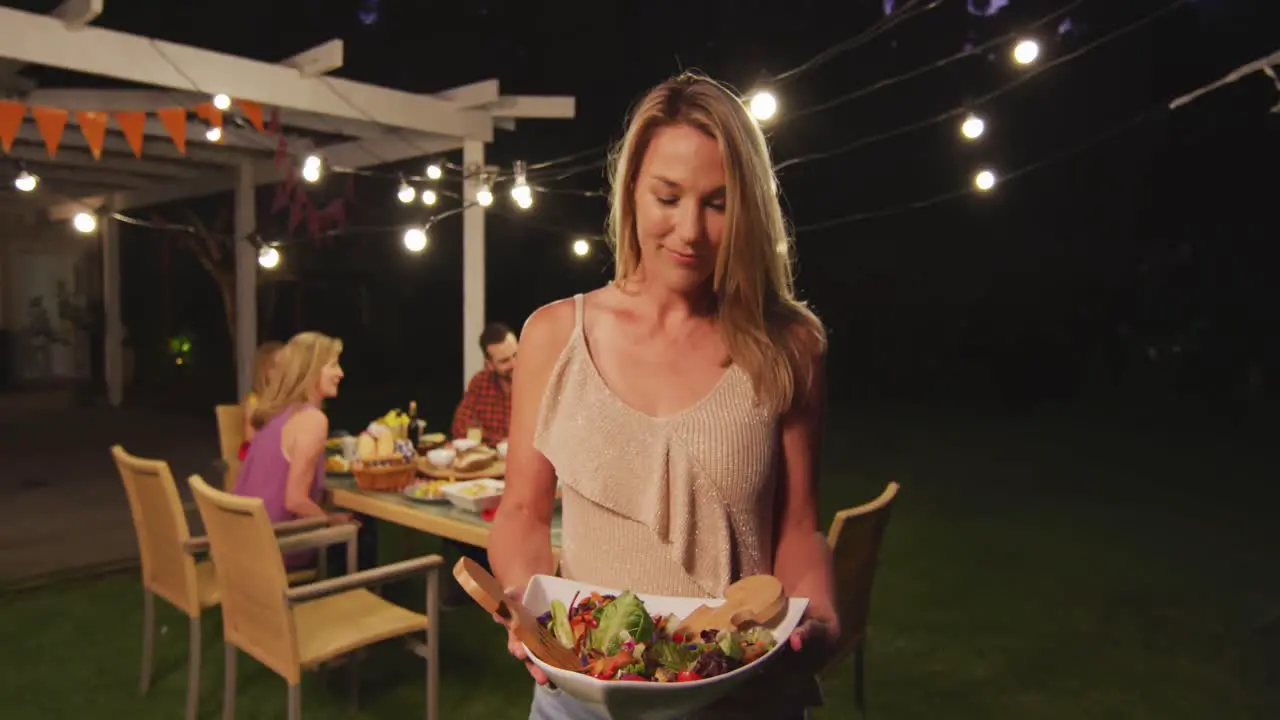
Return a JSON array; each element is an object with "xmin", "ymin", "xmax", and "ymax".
[{"xmin": 234, "ymin": 406, "xmax": 324, "ymax": 569}]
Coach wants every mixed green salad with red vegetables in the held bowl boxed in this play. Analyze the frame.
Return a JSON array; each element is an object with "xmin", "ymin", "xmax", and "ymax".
[{"xmin": 538, "ymin": 591, "xmax": 776, "ymax": 683}]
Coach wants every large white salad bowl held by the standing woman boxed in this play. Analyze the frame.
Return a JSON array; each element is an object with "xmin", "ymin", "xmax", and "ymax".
[{"xmin": 524, "ymin": 575, "xmax": 809, "ymax": 720}]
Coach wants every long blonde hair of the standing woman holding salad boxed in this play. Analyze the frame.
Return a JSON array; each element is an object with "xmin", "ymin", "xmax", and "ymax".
[{"xmin": 608, "ymin": 73, "xmax": 827, "ymax": 413}]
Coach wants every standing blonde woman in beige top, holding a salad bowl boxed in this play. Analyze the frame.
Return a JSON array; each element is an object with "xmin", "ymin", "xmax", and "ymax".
[{"xmin": 489, "ymin": 73, "xmax": 838, "ymax": 720}]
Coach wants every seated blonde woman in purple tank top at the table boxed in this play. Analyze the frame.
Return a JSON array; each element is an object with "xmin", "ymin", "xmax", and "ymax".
[{"xmin": 236, "ymin": 332, "xmax": 351, "ymax": 570}]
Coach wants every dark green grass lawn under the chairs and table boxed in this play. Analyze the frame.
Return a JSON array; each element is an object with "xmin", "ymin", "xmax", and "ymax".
[{"xmin": 0, "ymin": 413, "xmax": 1280, "ymax": 720}]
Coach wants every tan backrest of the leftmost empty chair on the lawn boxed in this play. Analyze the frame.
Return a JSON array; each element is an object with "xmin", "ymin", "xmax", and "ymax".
[{"xmin": 111, "ymin": 445, "xmax": 200, "ymax": 618}]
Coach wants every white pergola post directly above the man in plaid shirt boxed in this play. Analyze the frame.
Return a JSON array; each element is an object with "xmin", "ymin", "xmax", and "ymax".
[{"xmin": 462, "ymin": 140, "xmax": 485, "ymax": 389}]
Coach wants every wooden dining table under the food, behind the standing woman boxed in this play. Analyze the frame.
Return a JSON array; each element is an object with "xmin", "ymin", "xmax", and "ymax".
[{"xmin": 325, "ymin": 474, "xmax": 561, "ymax": 548}]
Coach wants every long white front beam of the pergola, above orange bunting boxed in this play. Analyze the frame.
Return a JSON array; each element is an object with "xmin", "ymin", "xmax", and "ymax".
[{"xmin": 0, "ymin": 6, "xmax": 493, "ymax": 142}]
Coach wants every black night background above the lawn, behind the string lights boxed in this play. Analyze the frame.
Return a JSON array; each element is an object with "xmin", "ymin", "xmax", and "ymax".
[{"xmin": 6, "ymin": 0, "xmax": 1280, "ymax": 412}]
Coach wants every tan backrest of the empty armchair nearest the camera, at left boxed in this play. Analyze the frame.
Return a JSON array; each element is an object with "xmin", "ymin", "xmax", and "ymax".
[{"xmin": 187, "ymin": 475, "xmax": 301, "ymax": 684}]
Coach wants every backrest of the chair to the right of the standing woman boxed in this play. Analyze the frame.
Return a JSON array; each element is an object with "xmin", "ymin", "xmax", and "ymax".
[{"xmin": 827, "ymin": 483, "xmax": 899, "ymax": 665}]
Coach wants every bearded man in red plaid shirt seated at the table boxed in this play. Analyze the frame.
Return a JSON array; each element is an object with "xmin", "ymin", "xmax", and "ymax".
[{"xmin": 444, "ymin": 323, "xmax": 518, "ymax": 607}]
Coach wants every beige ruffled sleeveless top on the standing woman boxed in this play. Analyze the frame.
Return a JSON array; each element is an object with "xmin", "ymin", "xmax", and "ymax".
[{"xmin": 534, "ymin": 295, "xmax": 778, "ymax": 597}]
